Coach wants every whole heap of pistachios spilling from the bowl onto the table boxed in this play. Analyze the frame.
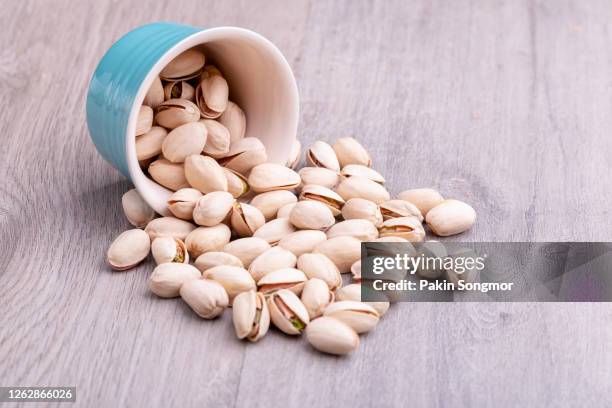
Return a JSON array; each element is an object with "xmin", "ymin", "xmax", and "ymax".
[{"xmin": 107, "ymin": 50, "xmax": 476, "ymax": 354}]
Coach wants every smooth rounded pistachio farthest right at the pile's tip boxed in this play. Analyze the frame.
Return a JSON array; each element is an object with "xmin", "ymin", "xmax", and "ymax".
[{"xmin": 426, "ymin": 200, "xmax": 476, "ymax": 237}]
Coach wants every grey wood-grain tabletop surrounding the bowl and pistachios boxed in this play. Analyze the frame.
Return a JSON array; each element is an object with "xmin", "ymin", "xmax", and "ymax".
[{"xmin": 0, "ymin": 0, "xmax": 612, "ymax": 407}]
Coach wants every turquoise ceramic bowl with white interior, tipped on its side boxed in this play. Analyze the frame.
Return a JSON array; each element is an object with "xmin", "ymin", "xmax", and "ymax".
[{"xmin": 87, "ymin": 23, "xmax": 299, "ymax": 215}]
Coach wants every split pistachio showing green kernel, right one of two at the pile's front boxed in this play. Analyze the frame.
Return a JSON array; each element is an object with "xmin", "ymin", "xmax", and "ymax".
[{"xmin": 268, "ymin": 289, "xmax": 310, "ymax": 335}]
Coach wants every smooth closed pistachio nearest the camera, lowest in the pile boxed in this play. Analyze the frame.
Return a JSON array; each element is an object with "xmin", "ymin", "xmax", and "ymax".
[{"xmin": 306, "ymin": 316, "xmax": 359, "ymax": 355}]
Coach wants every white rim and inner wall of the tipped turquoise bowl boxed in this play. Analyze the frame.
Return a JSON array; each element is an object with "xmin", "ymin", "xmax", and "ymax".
[{"xmin": 125, "ymin": 27, "xmax": 299, "ymax": 215}]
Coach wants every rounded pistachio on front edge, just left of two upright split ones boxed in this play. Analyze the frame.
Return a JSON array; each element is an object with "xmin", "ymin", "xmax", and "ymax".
[{"xmin": 179, "ymin": 279, "xmax": 229, "ymax": 319}]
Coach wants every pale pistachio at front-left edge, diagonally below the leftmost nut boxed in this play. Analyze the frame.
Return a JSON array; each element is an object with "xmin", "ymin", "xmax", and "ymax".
[{"xmin": 149, "ymin": 262, "xmax": 202, "ymax": 298}]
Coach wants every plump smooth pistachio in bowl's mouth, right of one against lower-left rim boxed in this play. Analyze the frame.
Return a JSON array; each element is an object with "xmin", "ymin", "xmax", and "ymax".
[{"xmin": 185, "ymin": 154, "xmax": 227, "ymax": 194}]
